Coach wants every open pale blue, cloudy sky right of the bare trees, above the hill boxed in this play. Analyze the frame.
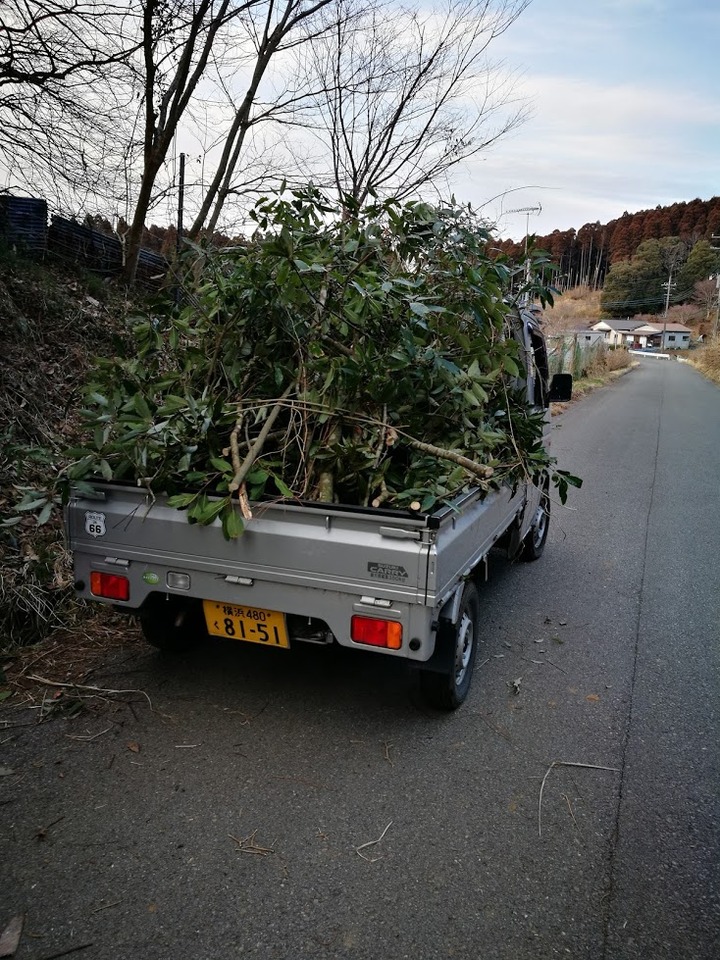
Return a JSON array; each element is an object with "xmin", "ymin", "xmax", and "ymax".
[{"xmin": 462, "ymin": 0, "xmax": 720, "ymax": 239}]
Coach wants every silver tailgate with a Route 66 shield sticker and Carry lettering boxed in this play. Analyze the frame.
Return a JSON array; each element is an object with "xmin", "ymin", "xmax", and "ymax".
[{"xmin": 66, "ymin": 485, "xmax": 431, "ymax": 607}]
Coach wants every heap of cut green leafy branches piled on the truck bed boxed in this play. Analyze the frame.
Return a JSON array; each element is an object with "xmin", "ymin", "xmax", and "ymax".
[{"xmin": 22, "ymin": 189, "xmax": 573, "ymax": 537}]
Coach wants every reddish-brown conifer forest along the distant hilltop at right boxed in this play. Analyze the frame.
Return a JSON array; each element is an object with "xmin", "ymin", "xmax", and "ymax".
[{"xmin": 499, "ymin": 197, "xmax": 720, "ymax": 289}]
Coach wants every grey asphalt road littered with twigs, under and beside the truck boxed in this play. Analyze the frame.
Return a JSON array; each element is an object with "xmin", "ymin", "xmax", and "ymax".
[{"xmin": 0, "ymin": 360, "xmax": 720, "ymax": 960}]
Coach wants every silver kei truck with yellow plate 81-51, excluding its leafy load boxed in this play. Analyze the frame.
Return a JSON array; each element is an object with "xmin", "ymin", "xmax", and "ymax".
[{"xmin": 66, "ymin": 312, "xmax": 572, "ymax": 710}]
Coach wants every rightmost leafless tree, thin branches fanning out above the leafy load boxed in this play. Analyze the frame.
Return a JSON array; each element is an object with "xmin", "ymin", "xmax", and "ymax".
[{"xmin": 296, "ymin": 0, "xmax": 530, "ymax": 203}]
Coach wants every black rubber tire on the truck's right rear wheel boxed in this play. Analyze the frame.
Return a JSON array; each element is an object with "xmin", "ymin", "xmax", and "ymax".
[{"xmin": 420, "ymin": 580, "xmax": 480, "ymax": 710}]
